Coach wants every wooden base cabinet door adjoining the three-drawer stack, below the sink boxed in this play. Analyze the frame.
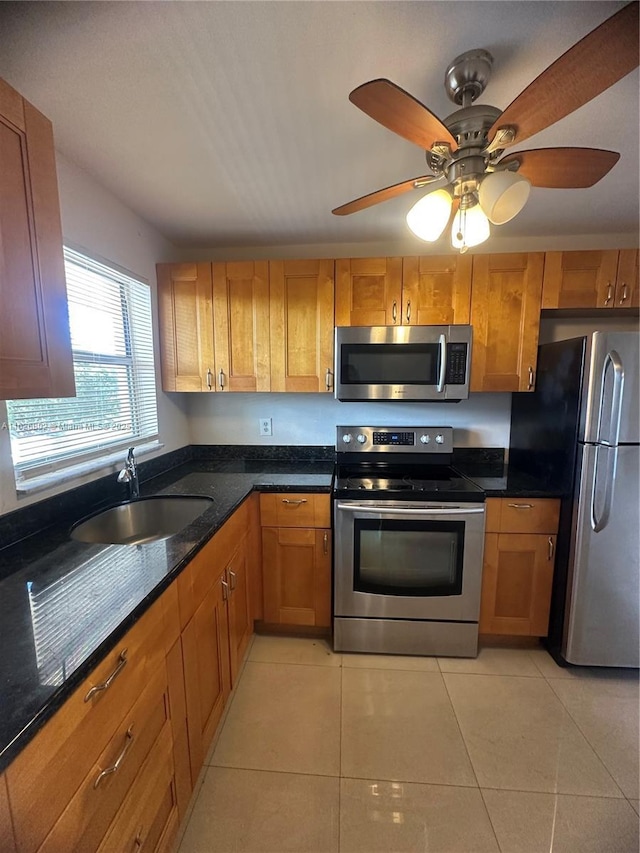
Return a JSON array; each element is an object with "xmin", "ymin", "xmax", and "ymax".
[{"xmin": 182, "ymin": 573, "xmax": 231, "ymax": 784}]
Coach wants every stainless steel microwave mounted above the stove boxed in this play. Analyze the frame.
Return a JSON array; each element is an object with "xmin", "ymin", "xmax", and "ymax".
[{"xmin": 335, "ymin": 325, "xmax": 471, "ymax": 402}]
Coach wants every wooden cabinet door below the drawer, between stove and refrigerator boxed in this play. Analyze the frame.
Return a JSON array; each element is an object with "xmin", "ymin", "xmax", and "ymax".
[{"xmin": 480, "ymin": 533, "xmax": 556, "ymax": 637}]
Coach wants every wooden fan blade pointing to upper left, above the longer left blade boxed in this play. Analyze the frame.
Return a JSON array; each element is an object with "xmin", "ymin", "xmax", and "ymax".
[{"xmin": 349, "ymin": 79, "xmax": 458, "ymax": 151}]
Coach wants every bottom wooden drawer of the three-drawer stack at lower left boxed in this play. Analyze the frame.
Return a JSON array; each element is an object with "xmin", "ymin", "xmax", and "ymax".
[{"xmin": 98, "ymin": 723, "xmax": 178, "ymax": 853}]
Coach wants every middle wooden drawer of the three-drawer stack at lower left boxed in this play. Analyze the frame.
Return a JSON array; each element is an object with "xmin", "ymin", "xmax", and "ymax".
[{"xmin": 39, "ymin": 666, "xmax": 169, "ymax": 853}]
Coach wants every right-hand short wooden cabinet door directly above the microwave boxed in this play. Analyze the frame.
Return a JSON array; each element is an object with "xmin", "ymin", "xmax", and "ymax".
[{"xmin": 402, "ymin": 255, "xmax": 472, "ymax": 326}]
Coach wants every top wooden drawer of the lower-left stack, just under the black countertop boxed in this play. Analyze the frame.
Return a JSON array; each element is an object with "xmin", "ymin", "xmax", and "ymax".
[{"xmin": 6, "ymin": 599, "xmax": 165, "ymax": 853}]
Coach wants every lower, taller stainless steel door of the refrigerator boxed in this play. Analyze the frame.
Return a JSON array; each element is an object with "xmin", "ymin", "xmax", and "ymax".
[{"xmin": 562, "ymin": 445, "xmax": 640, "ymax": 667}]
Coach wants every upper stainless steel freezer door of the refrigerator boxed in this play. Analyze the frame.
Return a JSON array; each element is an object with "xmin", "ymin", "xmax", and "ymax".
[{"xmin": 580, "ymin": 332, "xmax": 640, "ymax": 444}]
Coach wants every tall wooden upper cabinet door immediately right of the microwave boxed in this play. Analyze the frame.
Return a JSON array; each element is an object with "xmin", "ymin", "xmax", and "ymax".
[{"xmin": 470, "ymin": 252, "xmax": 544, "ymax": 391}]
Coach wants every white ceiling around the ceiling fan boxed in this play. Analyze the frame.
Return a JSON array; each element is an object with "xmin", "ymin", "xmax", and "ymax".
[{"xmin": 0, "ymin": 0, "xmax": 639, "ymax": 248}]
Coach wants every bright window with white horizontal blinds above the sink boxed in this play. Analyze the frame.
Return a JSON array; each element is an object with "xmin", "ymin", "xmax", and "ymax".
[{"xmin": 7, "ymin": 247, "xmax": 158, "ymax": 483}]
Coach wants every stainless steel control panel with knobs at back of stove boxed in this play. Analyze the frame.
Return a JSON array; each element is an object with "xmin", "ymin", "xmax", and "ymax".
[{"xmin": 336, "ymin": 426, "xmax": 453, "ymax": 453}]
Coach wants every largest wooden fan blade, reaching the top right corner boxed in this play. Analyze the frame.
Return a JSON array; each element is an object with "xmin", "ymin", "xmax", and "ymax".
[{"xmin": 488, "ymin": 2, "xmax": 640, "ymax": 148}]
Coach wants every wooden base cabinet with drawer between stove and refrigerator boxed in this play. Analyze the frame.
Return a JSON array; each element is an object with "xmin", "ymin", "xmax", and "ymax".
[{"xmin": 480, "ymin": 498, "xmax": 559, "ymax": 637}]
